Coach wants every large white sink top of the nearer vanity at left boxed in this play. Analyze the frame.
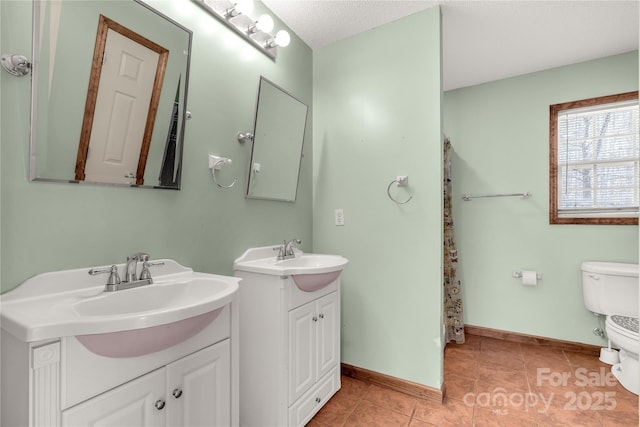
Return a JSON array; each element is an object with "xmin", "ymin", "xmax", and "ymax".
[{"xmin": 0, "ymin": 260, "xmax": 240, "ymax": 342}]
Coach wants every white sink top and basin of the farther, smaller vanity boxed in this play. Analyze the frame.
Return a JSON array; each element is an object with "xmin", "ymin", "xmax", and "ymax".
[{"xmin": 233, "ymin": 246, "xmax": 349, "ymax": 292}]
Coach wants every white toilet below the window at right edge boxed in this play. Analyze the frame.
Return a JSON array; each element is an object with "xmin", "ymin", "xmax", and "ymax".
[{"xmin": 582, "ymin": 261, "xmax": 640, "ymax": 394}]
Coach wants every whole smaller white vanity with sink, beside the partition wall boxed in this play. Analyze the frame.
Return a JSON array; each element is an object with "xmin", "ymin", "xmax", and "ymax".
[{"xmin": 234, "ymin": 246, "xmax": 348, "ymax": 427}]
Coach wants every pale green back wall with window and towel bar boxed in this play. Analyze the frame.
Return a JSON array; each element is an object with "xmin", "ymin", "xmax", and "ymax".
[{"xmin": 443, "ymin": 52, "xmax": 638, "ymax": 345}]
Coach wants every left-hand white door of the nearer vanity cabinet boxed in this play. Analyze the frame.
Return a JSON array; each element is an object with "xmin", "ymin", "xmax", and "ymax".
[{"xmin": 62, "ymin": 368, "xmax": 167, "ymax": 427}]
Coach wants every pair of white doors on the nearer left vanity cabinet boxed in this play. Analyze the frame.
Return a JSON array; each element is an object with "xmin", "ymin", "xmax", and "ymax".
[{"xmin": 62, "ymin": 339, "xmax": 231, "ymax": 427}]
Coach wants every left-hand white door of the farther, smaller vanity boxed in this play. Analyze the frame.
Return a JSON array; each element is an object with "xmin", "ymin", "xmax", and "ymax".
[{"xmin": 287, "ymin": 302, "xmax": 318, "ymax": 406}]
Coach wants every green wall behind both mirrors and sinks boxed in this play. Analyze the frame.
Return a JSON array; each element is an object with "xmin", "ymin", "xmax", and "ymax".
[{"xmin": 0, "ymin": 0, "xmax": 313, "ymax": 291}]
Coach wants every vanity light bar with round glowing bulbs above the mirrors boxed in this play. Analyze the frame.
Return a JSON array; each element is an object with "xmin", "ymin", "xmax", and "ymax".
[{"xmin": 192, "ymin": 0, "xmax": 291, "ymax": 60}]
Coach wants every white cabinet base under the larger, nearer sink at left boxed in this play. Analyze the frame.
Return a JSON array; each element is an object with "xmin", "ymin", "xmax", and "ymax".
[{"xmin": 2, "ymin": 303, "xmax": 238, "ymax": 427}]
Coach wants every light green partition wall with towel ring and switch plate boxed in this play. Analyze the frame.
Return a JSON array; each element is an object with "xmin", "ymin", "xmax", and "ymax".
[{"xmin": 313, "ymin": 8, "xmax": 442, "ymax": 388}]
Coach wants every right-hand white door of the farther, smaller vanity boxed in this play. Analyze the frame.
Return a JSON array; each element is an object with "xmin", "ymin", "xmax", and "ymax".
[{"xmin": 316, "ymin": 292, "xmax": 340, "ymax": 379}]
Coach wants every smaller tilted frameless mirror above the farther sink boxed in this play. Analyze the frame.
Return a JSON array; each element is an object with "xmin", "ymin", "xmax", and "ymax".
[{"xmin": 247, "ymin": 77, "xmax": 307, "ymax": 202}]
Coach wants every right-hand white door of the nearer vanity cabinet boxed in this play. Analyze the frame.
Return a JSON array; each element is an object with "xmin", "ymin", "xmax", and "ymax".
[{"xmin": 167, "ymin": 339, "xmax": 231, "ymax": 427}]
